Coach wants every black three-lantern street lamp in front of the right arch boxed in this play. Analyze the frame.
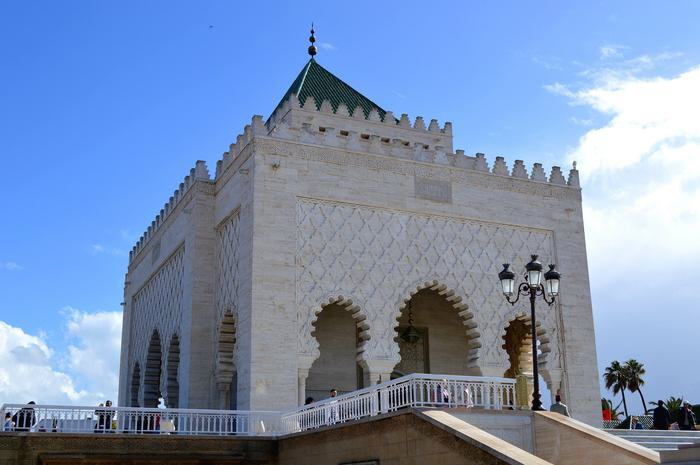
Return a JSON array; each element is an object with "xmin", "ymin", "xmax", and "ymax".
[{"xmin": 498, "ymin": 255, "xmax": 561, "ymax": 410}]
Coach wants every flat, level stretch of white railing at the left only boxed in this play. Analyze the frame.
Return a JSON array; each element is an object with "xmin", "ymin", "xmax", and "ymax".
[{"xmin": 0, "ymin": 404, "xmax": 280, "ymax": 436}]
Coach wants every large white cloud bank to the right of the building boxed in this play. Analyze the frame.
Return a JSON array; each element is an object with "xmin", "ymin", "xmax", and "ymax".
[{"xmin": 549, "ymin": 58, "xmax": 700, "ymax": 408}]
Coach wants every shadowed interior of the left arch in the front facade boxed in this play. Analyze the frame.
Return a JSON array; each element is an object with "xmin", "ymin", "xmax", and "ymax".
[{"xmin": 306, "ymin": 304, "xmax": 362, "ymax": 401}]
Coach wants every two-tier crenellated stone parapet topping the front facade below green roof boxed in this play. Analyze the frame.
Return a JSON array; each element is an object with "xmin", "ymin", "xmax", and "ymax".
[{"xmin": 260, "ymin": 95, "xmax": 580, "ymax": 188}]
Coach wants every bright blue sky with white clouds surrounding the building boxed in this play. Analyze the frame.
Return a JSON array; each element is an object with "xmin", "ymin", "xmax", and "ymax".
[{"xmin": 0, "ymin": 1, "xmax": 700, "ymax": 410}]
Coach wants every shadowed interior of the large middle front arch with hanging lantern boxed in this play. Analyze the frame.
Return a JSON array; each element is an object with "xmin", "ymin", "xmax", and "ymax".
[{"xmin": 392, "ymin": 289, "xmax": 479, "ymax": 377}]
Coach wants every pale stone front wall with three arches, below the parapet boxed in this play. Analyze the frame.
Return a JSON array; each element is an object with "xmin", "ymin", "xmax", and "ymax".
[{"xmin": 251, "ymin": 130, "xmax": 599, "ymax": 423}]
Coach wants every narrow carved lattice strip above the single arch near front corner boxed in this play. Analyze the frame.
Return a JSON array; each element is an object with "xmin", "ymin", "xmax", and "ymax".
[{"xmin": 214, "ymin": 212, "xmax": 240, "ymax": 362}]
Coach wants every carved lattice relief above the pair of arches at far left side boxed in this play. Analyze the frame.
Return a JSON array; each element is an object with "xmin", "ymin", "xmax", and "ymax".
[{"xmin": 129, "ymin": 246, "xmax": 185, "ymax": 393}]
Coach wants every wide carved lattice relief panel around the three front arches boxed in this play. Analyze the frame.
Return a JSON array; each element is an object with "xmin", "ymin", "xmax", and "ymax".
[{"xmin": 296, "ymin": 199, "xmax": 559, "ymax": 374}]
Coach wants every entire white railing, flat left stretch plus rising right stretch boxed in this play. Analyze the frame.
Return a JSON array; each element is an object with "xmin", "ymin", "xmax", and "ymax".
[{"xmin": 0, "ymin": 374, "xmax": 515, "ymax": 436}]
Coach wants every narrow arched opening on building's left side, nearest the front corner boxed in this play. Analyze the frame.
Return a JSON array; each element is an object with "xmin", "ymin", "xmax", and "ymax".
[{"xmin": 216, "ymin": 311, "xmax": 238, "ymax": 410}]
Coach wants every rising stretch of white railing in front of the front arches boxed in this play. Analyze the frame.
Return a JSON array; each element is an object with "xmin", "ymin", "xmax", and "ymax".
[{"xmin": 281, "ymin": 373, "xmax": 515, "ymax": 433}]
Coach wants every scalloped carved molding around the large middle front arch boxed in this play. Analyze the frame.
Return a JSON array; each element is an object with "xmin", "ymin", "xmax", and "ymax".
[{"xmin": 392, "ymin": 279, "xmax": 481, "ymax": 370}]
